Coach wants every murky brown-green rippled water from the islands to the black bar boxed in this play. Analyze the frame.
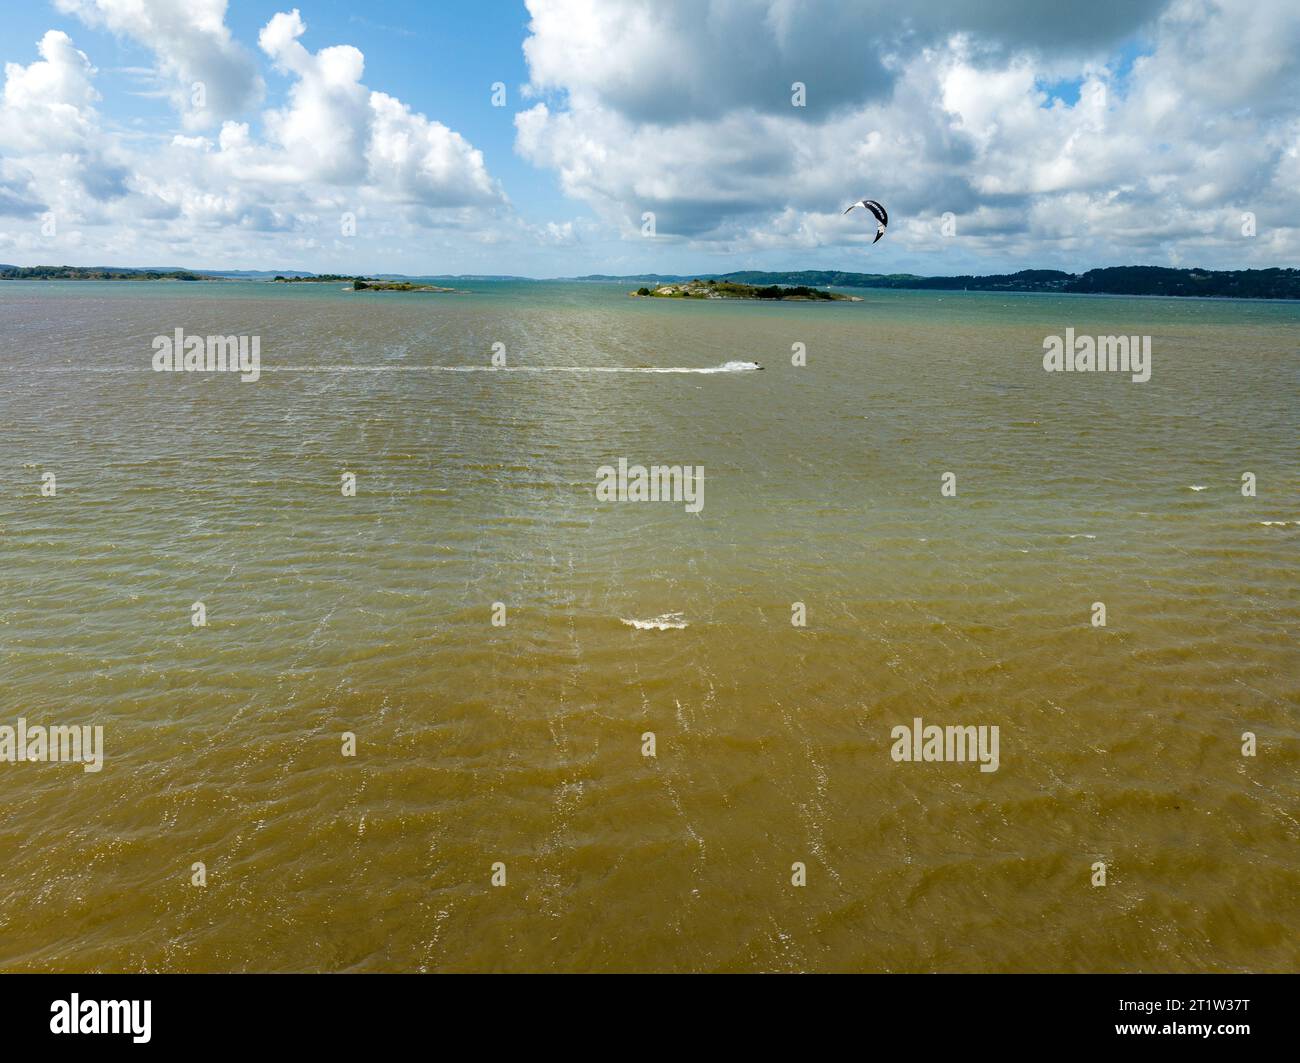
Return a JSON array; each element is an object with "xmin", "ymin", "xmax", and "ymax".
[{"xmin": 0, "ymin": 283, "xmax": 1300, "ymax": 971}]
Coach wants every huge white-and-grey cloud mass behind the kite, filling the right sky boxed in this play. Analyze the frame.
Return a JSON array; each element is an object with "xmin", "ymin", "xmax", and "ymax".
[{"xmin": 516, "ymin": 0, "xmax": 1300, "ymax": 265}]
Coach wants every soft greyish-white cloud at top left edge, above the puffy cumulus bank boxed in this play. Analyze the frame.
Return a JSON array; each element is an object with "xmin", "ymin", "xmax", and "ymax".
[{"xmin": 55, "ymin": 0, "xmax": 263, "ymax": 129}]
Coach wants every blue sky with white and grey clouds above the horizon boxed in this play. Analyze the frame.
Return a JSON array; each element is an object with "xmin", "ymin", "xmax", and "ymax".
[{"xmin": 0, "ymin": 0, "xmax": 1300, "ymax": 277}]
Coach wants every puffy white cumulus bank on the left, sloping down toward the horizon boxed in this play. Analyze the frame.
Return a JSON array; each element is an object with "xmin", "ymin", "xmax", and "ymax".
[{"xmin": 0, "ymin": 9, "xmax": 510, "ymax": 260}]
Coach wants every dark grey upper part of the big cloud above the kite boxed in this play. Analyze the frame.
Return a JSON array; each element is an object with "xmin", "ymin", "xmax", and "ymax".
[{"xmin": 524, "ymin": 0, "xmax": 1165, "ymax": 123}]
